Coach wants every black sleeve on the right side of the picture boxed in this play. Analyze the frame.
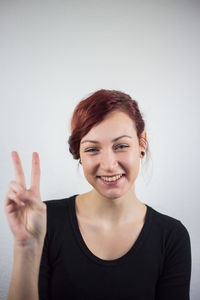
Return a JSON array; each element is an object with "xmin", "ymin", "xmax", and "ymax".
[{"xmin": 155, "ymin": 221, "xmax": 191, "ymax": 300}]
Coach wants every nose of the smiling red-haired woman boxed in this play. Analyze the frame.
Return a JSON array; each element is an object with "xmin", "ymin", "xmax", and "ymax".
[{"xmin": 100, "ymin": 150, "xmax": 118, "ymax": 174}]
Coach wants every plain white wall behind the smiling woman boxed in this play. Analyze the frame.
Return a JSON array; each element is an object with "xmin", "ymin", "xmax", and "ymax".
[{"xmin": 0, "ymin": 0, "xmax": 200, "ymax": 300}]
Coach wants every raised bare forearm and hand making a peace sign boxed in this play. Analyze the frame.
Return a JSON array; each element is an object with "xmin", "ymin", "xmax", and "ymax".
[{"xmin": 5, "ymin": 152, "xmax": 47, "ymax": 300}]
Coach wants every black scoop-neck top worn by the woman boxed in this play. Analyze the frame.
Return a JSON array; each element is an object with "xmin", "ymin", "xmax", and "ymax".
[{"xmin": 38, "ymin": 195, "xmax": 191, "ymax": 300}]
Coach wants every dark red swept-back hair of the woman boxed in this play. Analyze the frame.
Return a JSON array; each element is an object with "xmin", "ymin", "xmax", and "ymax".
[{"xmin": 68, "ymin": 89, "xmax": 148, "ymax": 159}]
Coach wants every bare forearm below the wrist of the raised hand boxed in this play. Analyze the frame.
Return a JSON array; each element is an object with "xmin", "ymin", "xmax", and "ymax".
[{"xmin": 7, "ymin": 244, "xmax": 42, "ymax": 300}]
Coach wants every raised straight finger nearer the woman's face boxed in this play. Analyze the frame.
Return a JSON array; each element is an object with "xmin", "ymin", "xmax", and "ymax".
[{"xmin": 31, "ymin": 152, "xmax": 40, "ymax": 193}]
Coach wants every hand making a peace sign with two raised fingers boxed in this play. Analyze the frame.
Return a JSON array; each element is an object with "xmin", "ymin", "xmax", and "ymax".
[{"xmin": 5, "ymin": 151, "xmax": 46, "ymax": 247}]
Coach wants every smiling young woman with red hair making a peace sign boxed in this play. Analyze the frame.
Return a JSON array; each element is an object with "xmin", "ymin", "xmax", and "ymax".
[{"xmin": 5, "ymin": 90, "xmax": 191, "ymax": 300}]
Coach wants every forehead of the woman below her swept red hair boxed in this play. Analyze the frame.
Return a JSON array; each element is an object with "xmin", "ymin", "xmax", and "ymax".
[{"xmin": 82, "ymin": 111, "xmax": 136, "ymax": 140}]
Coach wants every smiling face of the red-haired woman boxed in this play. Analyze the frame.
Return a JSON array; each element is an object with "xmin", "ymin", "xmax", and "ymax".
[{"xmin": 80, "ymin": 111, "xmax": 146, "ymax": 199}]
